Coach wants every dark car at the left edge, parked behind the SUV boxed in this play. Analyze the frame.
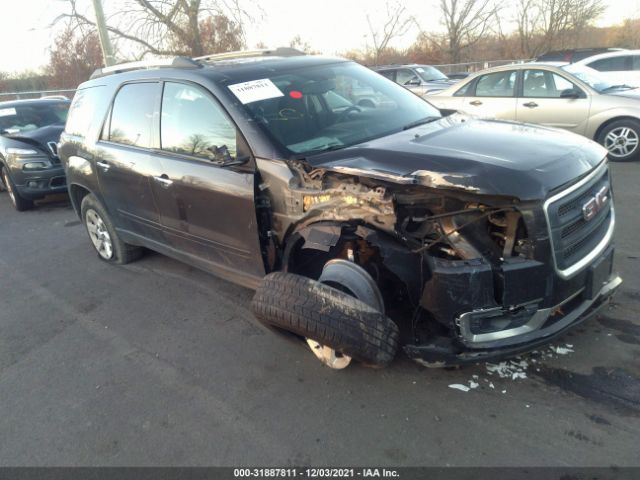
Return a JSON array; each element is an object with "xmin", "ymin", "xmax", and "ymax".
[{"xmin": 0, "ymin": 99, "xmax": 70, "ymax": 211}]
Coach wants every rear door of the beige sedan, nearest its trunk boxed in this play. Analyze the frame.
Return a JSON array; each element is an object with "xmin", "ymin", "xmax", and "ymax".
[{"xmin": 460, "ymin": 70, "xmax": 518, "ymax": 120}]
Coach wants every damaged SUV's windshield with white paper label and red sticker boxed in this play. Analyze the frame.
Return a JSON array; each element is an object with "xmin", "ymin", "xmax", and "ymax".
[{"xmin": 229, "ymin": 63, "xmax": 441, "ymax": 157}]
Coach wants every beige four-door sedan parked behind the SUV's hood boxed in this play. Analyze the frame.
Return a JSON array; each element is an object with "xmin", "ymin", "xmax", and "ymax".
[{"xmin": 428, "ymin": 63, "xmax": 640, "ymax": 161}]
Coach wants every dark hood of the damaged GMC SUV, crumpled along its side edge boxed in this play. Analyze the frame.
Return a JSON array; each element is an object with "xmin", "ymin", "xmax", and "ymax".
[{"xmin": 307, "ymin": 114, "xmax": 607, "ymax": 201}]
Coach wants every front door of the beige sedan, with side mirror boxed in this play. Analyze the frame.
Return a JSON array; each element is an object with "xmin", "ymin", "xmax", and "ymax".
[{"xmin": 517, "ymin": 69, "xmax": 591, "ymax": 135}]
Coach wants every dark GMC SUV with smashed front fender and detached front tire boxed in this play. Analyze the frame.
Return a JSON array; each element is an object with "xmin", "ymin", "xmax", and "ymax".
[{"xmin": 59, "ymin": 49, "xmax": 621, "ymax": 368}]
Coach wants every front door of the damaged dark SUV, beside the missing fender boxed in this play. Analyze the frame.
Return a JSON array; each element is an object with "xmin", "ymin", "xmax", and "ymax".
[{"xmin": 154, "ymin": 82, "xmax": 264, "ymax": 276}]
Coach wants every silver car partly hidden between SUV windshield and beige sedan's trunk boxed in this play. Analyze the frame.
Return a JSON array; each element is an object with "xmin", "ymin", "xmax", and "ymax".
[{"xmin": 372, "ymin": 64, "xmax": 455, "ymax": 95}]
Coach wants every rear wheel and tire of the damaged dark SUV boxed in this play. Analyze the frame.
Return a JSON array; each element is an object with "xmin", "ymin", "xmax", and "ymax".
[{"xmin": 80, "ymin": 194, "xmax": 142, "ymax": 265}]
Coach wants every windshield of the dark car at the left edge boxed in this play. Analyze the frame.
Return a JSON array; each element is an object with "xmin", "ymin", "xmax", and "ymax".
[{"xmin": 0, "ymin": 102, "xmax": 69, "ymax": 135}]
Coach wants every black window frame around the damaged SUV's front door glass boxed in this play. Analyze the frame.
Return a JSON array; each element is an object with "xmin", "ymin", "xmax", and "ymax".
[{"xmin": 158, "ymin": 78, "xmax": 256, "ymax": 172}]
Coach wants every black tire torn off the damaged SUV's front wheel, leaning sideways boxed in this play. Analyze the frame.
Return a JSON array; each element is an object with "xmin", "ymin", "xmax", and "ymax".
[{"xmin": 252, "ymin": 272, "xmax": 399, "ymax": 367}]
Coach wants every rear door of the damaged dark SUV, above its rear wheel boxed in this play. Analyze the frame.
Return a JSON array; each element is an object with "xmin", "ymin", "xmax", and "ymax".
[{"xmin": 95, "ymin": 82, "xmax": 163, "ymax": 241}]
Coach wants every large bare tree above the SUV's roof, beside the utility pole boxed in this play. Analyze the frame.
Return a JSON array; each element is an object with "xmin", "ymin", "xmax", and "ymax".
[{"xmin": 56, "ymin": 0, "xmax": 250, "ymax": 57}]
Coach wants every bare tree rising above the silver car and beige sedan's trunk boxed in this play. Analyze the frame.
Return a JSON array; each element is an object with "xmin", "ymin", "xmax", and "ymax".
[{"xmin": 440, "ymin": 0, "xmax": 500, "ymax": 63}]
